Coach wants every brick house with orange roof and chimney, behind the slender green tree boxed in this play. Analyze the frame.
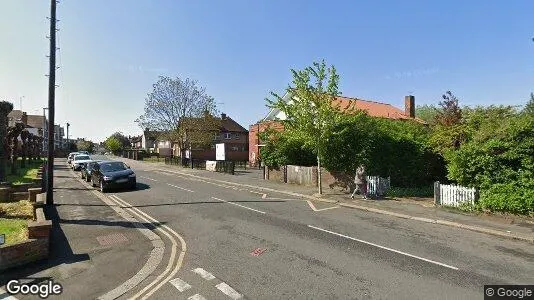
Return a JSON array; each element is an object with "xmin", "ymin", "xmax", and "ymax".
[{"xmin": 248, "ymin": 93, "xmax": 425, "ymax": 166}]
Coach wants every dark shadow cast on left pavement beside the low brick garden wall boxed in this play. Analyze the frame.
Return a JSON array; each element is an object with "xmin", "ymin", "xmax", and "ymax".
[{"xmin": 0, "ymin": 205, "xmax": 90, "ymax": 285}]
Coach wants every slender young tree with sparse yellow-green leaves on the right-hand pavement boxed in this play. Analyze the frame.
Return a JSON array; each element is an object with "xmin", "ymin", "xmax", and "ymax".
[{"xmin": 266, "ymin": 60, "xmax": 348, "ymax": 193}]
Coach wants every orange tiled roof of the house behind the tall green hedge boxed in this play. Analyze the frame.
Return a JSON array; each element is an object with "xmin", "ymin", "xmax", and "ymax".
[{"xmin": 263, "ymin": 93, "xmax": 426, "ymax": 123}]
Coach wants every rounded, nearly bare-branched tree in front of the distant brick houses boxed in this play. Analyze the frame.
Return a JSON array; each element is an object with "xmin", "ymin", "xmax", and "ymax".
[{"xmin": 135, "ymin": 76, "xmax": 219, "ymax": 155}]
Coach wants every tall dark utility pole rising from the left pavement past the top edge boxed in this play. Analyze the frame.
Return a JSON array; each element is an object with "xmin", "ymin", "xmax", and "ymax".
[{"xmin": 46, "ymin": 0, "xmax": 56, "ymax": 205}]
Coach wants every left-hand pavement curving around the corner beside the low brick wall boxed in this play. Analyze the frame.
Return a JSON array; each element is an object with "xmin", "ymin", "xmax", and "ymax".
[{"xmin": 0, "ymin": 160, "xmax": 152, "ymax": 299}]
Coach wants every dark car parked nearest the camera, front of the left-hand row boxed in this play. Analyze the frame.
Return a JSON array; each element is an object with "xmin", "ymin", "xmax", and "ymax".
[{"xmin": 91, "ymin": 160, "xmax": 137, "ymax": 193}]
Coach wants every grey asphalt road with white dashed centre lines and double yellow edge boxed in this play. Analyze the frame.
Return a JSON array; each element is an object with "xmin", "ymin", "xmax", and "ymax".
[{"xmin": 80, "ymin": 157, "xmax": 534, "ymax": 299}]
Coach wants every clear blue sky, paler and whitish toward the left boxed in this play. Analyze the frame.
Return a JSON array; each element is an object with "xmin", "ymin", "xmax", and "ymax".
[{"xmin": 0, "ymin": 0, "xmax": 534, "ymax": 142}]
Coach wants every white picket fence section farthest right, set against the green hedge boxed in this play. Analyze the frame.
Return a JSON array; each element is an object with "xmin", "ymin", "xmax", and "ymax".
[{"xmin": 434, "ymin": 182, "xmax": 477, "ymax": 207}]
